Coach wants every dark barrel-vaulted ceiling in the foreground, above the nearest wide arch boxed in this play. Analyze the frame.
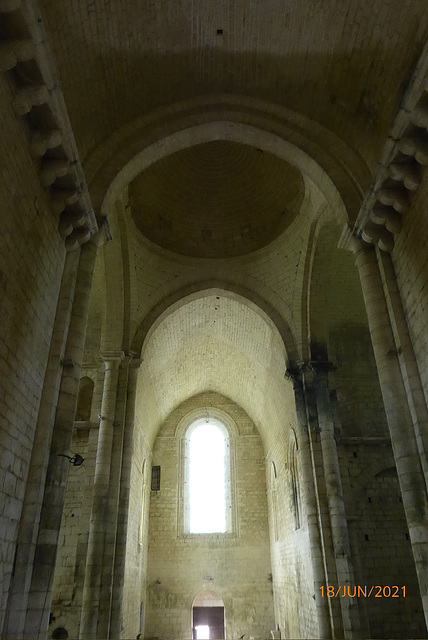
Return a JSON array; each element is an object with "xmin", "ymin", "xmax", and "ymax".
[{"xmin": 40, "ymin": 0, "xmax": 427, "ymax": 166}]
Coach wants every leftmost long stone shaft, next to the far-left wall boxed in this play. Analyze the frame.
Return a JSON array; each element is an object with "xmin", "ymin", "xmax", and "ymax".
[{"xmin": 2, "ymin": 246, "xmax": 80, "ymax": 638}]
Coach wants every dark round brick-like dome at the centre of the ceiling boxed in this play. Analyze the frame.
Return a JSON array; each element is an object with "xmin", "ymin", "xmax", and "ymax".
[{"xmin": 129, "ymin": 140, "xmax": 305, "ymax": 258}]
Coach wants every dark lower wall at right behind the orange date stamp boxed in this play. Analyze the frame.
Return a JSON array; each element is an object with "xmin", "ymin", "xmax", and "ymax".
[{"xmin": 340, "ymin": 438, "xmax": 426, "ymax": 638}]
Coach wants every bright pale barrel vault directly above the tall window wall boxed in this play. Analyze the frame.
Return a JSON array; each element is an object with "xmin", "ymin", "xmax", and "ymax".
[{"xmin": 136, "ymin": 290, "xmax": 294, "ymax": 444}]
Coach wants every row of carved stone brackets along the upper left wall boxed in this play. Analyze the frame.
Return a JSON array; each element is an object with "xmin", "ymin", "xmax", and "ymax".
[{"xmin": 0, "ymin": 0, "xmax": 98, "ymax": 251}]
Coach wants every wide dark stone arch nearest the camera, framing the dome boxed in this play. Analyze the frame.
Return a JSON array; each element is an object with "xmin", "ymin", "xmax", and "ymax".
[{"xmin": 85, "ymin": 94, "xmax": 370, "ymax": 222}]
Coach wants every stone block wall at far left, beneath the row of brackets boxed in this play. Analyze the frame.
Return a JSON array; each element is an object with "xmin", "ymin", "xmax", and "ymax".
[{"xmin": 0, "ymin": 75, "xmax": 65, "ymax": 629}]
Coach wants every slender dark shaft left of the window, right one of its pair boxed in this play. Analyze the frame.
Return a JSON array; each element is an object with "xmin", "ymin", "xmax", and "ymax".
[{"xmin": 109, "ymin": 359, "xmax": 141, "ymax": 638}]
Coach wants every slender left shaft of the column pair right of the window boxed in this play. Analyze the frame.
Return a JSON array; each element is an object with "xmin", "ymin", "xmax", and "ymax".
[{"xmin": 287, "ymin": 370, "xmax": 332, "ymax": 638}]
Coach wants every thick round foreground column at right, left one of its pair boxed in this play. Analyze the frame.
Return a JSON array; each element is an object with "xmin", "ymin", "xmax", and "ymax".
[{"xmin": 353, "ymin": 240, "xmax": 428, "ymax": 625}]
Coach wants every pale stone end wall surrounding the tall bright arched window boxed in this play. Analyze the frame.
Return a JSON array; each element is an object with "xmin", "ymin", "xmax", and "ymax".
[{"xmin": 145, "ymin": 393, "xmax": 274, "ymax": 639}]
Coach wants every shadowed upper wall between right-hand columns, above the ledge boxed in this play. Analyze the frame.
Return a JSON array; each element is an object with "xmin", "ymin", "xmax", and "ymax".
[{"xmin": 310, "ymin": 221, "xmax": 388, "ymax": 436}]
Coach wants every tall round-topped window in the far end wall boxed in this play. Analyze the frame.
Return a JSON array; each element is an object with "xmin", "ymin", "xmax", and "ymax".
[{"xmin": 184, "ymin": 418, "xmax": 231, "ymax": 533}]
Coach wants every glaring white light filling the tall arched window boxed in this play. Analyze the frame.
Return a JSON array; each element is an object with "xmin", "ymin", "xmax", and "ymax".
[{"xmin": 189, "ymin": 423, "xmax": 226, "ymax": 532}]
